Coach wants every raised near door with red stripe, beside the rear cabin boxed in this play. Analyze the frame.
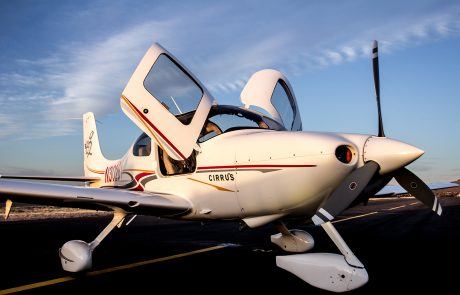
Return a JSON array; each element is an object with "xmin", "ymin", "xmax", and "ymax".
[{"xmin": 121, "ymin": 44, "xmax": 214, "ymax": 160}]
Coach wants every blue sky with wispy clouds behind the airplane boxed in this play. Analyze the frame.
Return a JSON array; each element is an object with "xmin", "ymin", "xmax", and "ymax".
[{"xmin": 0, "ymin": 0, "xmax": 460, "ymax": 181}]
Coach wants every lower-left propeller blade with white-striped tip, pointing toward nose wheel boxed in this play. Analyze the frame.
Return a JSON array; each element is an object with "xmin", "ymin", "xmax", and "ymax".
[{"xmin": 311, "ymin": 161, "xmax": 379, "ymax": 225}]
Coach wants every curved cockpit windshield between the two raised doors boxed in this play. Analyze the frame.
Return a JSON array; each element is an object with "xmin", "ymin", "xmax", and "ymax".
[{"xmin": 198, "ymin": 106, "xmax": 285, "ymax": 142}]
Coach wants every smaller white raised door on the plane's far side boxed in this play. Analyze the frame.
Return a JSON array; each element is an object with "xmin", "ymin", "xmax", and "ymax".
[{"xmin": 241, "ymin": 69, "xmax": 302, "ymax": 131}]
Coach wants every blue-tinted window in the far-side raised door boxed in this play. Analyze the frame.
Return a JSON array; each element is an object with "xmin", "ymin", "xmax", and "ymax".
[{"xmin": 271, "ymin": 80, "xmax": 296, "ymax": 129}]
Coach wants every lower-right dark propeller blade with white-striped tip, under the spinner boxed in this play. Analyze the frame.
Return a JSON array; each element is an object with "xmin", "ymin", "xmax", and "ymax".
[{"xmin": 394, "ymin": 168, "xmax": 442, "ymax": 215}]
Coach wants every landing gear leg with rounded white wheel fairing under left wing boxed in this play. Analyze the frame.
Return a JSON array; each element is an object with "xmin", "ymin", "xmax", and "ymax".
[{"xmin": 59, "ymin": 211, "xmax": 127, "ymax": 272}]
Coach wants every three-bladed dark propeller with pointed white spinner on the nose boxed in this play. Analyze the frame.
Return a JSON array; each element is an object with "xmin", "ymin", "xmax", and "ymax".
[{"xmin": 312, "ymin": 41, "xmax": 442, "ymax": 225}]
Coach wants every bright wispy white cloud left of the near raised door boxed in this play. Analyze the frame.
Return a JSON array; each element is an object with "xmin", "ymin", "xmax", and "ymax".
[{"xmin": 0, "ymin": 22, "xmax": 178, "ymax": 139}]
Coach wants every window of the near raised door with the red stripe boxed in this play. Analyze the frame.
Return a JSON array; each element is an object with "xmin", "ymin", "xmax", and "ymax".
[{"xmin": 144, "ymin": 54, "xmax": 203, "ymax": 122}]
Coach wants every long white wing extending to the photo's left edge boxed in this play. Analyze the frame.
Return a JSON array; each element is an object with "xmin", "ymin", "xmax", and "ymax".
[{"xmin": 0, "ymin": 178, "xmax": 192, "ymax": 217}]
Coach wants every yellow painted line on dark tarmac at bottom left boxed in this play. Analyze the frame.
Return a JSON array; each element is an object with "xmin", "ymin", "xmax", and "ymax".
[{"xmin": 0, "ymin": 245, "xmax": 227, "ymax": 295}]
